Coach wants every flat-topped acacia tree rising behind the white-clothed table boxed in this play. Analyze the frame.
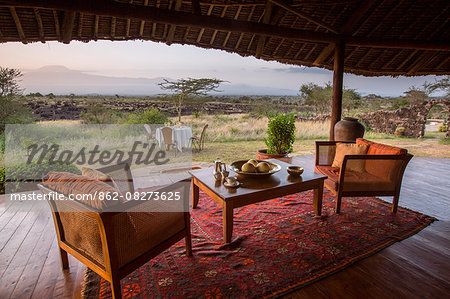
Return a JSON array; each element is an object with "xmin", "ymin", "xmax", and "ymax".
[{"xmin": 158, "ymin": 78, "xmax": 225, "ymax": 121}]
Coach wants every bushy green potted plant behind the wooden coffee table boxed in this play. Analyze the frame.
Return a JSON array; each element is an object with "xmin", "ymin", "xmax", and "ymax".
[{"xmin": 256, "ymin": 114, "xmax": 295, "ymax": 160}]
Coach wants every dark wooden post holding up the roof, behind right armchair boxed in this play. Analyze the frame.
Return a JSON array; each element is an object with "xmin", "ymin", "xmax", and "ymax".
[{"xmin": 330, "ymin": 41, "xmax": 345, "ymax": 141}]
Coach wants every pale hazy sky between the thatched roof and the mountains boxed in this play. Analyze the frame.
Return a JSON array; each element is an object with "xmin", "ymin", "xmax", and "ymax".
[{"xmin": 0, "ymin": 41, "xmax": 438, "ymax": 96}]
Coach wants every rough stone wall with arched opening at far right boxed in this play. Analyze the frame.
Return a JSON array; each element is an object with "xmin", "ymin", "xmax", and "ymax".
[{"xmin": 359, "ymin": 100, "xmax": 450, "ymax": 138}]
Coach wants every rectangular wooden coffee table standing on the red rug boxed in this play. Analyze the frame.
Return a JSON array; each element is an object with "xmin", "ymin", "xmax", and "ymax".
[{"xmin": 190, "ymin": 159, "xmax": 327, "ymax": 243}]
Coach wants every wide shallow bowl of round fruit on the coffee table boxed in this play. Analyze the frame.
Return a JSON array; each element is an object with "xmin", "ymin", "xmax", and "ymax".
[{"xmin": 230, "ymin": 159, "xmax": 281, "ymax": 177}]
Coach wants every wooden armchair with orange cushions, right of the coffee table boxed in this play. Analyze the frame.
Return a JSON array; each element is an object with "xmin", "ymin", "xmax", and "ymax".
[{"xmin": 315, "ymin": 138, "xmax": 413, "ymax": 214}]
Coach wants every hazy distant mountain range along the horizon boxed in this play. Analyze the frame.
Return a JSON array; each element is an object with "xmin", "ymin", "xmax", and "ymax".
[{"xmin": 20, "ymin": 65, "xmax": 297, "ymax": 96}]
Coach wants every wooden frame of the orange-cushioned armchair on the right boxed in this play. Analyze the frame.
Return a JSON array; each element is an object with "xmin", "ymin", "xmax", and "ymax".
[{"xmin": 315, "ymin": 141, "xmax": 413, "ymax": 214}]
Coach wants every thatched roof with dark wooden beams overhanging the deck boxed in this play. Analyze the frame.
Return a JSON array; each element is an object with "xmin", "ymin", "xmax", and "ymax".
[{"xmin": 0, "ymin": 0, "xmax": 450, "ymax": 76}]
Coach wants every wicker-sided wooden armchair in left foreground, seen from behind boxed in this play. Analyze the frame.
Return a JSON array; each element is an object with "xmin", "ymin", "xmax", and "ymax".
[{"xmin": 39, "ymin": 164, "xmax": 192, "ymax": 298}]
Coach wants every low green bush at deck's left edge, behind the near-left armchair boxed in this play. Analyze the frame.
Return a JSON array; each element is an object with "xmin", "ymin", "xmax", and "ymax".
[{"xmin": 4, "ymin": 161, "xmax": 81, "ymax": 192}]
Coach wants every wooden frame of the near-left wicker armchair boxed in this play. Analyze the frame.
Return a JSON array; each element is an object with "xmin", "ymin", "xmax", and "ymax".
[{"xmin": 38, "ymin": 166, "xmax": 192, "ymax": 298}]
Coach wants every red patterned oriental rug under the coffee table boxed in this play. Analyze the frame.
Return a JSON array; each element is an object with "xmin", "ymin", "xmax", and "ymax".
[{"xmin": 82, "ymin": 189, "xmax": 435, "ymax": 298}]
